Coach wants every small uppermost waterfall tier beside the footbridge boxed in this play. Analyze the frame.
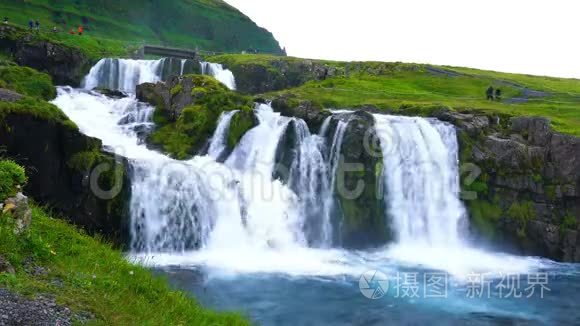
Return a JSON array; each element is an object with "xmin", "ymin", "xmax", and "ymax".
[{"xmin": 83, "ymin": 58, "xmax": 236, "ymax": 93}]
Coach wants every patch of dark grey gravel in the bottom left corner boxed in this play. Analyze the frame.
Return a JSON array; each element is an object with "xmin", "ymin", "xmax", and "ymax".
[{"xmin": 0, "ymin": 289, "xmax": 79, "ymax": 326}]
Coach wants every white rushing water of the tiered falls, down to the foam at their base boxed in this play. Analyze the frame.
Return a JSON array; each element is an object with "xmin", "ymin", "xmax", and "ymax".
[{"xmin": 54, "ymin": 59, "xmax": 548, "ymax": 275}]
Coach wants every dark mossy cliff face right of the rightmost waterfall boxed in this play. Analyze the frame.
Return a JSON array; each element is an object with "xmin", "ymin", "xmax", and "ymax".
[{"xmin": 452, "ymin": 117, "xmax": 580, "ymax": 262}]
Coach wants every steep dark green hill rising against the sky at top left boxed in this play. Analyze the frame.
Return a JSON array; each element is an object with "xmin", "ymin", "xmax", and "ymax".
[{"xmin": 0, "ymin": 0, "xmax": 281, "ymax": 53}]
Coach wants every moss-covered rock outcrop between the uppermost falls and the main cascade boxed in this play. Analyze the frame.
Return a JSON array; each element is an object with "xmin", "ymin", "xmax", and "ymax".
[{"xmin": 137, "ymin": 75, "xmax": 258, "ymax": 159}]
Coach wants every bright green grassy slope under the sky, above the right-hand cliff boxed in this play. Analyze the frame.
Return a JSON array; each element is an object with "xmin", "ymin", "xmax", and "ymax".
[{"xmin": 209, "ymin": 55, "xmax": 580, "ymax": 136}]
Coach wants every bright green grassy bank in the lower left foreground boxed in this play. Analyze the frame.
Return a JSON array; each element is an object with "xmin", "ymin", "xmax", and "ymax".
[{"xmin": 0, "ymin": 207, "xmax": 248, "ymax": 325}]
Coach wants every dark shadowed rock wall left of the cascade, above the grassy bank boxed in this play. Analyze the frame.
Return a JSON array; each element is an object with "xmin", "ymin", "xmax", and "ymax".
[{"xmin": 0, "ymin": 113, "xmax": 130, "ymax": 246}]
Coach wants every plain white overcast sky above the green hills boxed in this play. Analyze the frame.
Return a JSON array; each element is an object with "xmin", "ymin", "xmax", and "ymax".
[{"xmin": 226, "ymin": 0, "xmax": 580, "ymax": 78}]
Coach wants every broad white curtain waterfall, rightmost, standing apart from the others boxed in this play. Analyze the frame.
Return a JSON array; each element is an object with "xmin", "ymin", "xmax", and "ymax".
[{"xmin": 374, "ymin": 115, "xmax": 465, "ymax": 248}]
